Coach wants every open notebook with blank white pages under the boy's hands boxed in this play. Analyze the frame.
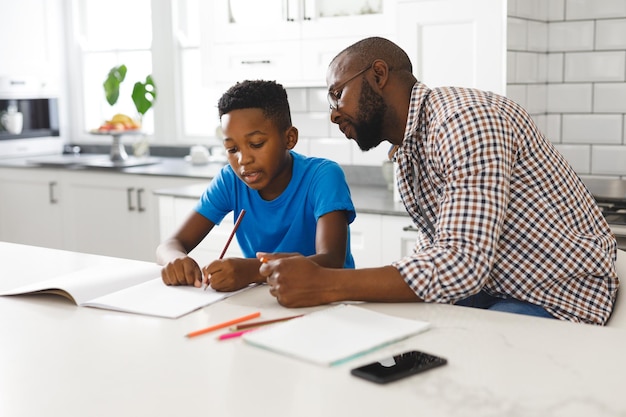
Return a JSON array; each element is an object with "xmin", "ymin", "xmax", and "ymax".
[{"xmin": 0, "ymin": 258, "xmax": 244, "ymax": 318}]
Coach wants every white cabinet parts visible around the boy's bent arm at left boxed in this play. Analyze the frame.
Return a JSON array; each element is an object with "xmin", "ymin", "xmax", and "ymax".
[{"xmin": 158, "ymin": 195, "xmax": 243, "ymax": 266}]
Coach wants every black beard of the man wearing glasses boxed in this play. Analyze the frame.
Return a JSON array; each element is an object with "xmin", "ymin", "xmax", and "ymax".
[{"xmin": 354, "ymin": 77, "xmax": 387, "ymax": 151}]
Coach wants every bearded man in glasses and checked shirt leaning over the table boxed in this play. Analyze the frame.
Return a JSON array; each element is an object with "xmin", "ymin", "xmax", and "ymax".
[{"xmin": 258, "ymin": 38, "xmax": 618, "ymax": 324}]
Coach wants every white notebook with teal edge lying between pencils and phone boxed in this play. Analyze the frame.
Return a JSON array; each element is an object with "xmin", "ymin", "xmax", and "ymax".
[{"xmin": 243, "ymin": 304, "xmax": 429, "ymax": 366}]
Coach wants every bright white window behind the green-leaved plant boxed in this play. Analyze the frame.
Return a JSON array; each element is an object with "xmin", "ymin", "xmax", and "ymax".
[{"xmin": 69, "ymin": 0, "xmax": 219, "ymax": 145}]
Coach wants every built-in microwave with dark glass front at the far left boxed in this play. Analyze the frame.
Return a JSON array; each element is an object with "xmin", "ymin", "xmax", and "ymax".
[{"xmin": 0, "ymin": 77, "xmax": 63, "ymax": 158}]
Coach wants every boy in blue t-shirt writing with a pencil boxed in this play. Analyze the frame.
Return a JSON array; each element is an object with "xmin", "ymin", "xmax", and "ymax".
[{"xmin": 157, "ymin": 80, "xmax": 356, "ymax": 291}]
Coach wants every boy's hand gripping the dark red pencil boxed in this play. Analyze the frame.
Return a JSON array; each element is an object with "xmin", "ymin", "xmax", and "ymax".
[{"xmin": 202, "ymin": 258, "xmax": 264, "ymax": 292}]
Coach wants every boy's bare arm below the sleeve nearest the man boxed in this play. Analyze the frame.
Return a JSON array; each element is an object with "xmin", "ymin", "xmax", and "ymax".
[{"xmin": 308, "ymin": 210, "xmax": 348, "ymax": 268}]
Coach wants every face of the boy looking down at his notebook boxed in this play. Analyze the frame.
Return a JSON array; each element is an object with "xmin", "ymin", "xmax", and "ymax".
[{"xmin": 221, "ymin": 108, "xmax": 298, "ymax": 200}]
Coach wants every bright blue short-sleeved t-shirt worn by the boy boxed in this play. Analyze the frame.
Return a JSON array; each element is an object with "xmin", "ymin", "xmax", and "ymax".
[{"xmin": 196, "ymin": 151, "xmax": 356, "ymax": 268}]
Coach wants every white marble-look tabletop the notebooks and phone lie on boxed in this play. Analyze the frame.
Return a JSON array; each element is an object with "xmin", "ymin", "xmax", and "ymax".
[{"xmin": 0, "ymin": 240, "xmax": 626, "ymax": 417}]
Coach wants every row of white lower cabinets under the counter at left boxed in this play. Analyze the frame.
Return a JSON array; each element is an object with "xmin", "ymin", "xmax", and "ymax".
[{"xmin": 0, "ymin": 168, "xmax": 207, "ymax": 261}]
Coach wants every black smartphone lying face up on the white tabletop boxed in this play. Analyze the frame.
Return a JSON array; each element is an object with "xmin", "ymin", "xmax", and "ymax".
[{"xmin": 350, "ymin": 350, "xmax": 448, "ymax": 384}]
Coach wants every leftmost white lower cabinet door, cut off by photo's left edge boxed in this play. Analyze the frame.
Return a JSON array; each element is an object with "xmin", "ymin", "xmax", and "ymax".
[{"xmin": 0, "ymin": 168, "xmax": 64, "ymax": 249}]
